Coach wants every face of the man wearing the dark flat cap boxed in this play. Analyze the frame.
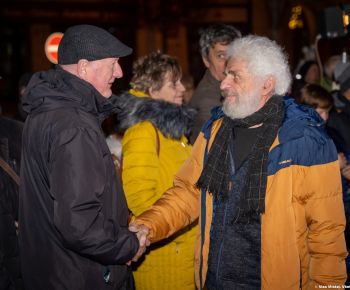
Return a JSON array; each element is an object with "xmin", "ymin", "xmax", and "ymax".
[{"xmin": 84, "ymin": 58, "xmax": 123, "ymax": 98}]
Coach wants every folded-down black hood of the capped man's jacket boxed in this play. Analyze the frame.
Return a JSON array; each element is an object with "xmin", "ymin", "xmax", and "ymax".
[{"xmin": 23, "ymin": 66, "xmax": 117, "ymax": 121}]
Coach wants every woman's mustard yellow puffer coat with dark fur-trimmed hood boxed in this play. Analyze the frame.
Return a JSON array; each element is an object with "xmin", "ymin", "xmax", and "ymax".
[{"xmin": 114, "ymin": 94, "xmax": 198, "ymax": 290}]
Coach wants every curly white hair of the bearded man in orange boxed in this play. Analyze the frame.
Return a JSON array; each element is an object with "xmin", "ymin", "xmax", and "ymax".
[{"xmin": 227, "ymin": 35, "xmax": 292, "ymax": 95}]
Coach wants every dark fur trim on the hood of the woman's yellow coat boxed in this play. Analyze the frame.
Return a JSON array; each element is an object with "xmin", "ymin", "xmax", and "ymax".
[{"xmin": 114, "ymin": 92, "xmax": 196, "ymax": 140}]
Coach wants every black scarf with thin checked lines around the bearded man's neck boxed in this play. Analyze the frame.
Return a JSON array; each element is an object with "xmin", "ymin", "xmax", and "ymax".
[{"xmin": 197, "ymin": 96, "xmax": 284, "ymax": 220}]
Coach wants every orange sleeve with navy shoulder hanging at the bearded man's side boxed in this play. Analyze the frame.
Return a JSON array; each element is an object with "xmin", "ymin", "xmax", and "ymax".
[{"xmin": 298, "ymin": 136, "xmax": 347, "ymax": 289}]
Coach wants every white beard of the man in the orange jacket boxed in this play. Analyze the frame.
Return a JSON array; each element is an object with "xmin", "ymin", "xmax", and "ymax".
[{"xmin": 222, "ymin": 89, "xmax": 261, "ymax": 119}]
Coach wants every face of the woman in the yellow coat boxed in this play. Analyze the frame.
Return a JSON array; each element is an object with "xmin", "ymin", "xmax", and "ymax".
[{"xmin": 149, "ymin": 73, "xmax": 185, "ymax": 105}]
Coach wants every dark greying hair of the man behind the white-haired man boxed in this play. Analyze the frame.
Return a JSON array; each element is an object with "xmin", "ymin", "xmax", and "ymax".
[{"xmin": 199, "ymin": 23, "xmax": 242, "ymax": 57}]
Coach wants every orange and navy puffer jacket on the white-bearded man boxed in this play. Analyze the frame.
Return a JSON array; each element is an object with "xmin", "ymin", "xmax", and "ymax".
[{"xmin": 136, "ymin": 98, "xmax": 347, "ymax": 290}]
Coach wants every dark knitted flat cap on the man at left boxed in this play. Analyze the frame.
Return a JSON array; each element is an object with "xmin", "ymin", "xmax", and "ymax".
[{"xmin": 58, "ymin": 24, "xmax": 132, "ymax": 64}]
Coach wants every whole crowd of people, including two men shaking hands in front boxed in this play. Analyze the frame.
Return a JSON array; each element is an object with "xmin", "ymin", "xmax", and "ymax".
[{"xmin": 0, "ymin": 24, "xmax": 350, "ymax": 290}]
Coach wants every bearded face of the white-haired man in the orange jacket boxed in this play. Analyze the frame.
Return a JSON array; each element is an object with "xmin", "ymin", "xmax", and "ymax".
[{"xmin": 220, "ymin": 58, "xmax": 266, "ymax": 119}]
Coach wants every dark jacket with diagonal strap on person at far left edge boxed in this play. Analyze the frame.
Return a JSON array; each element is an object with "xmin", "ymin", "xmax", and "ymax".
[{"xmin": 0, "ymin": 116, "xmax": 23, "ymax": 290}]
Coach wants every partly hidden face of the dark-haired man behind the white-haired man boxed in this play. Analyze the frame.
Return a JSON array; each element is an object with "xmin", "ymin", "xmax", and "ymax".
[{"xmin": 203, "ymin": 43, "xmax": 227, "ymax": 81}]
